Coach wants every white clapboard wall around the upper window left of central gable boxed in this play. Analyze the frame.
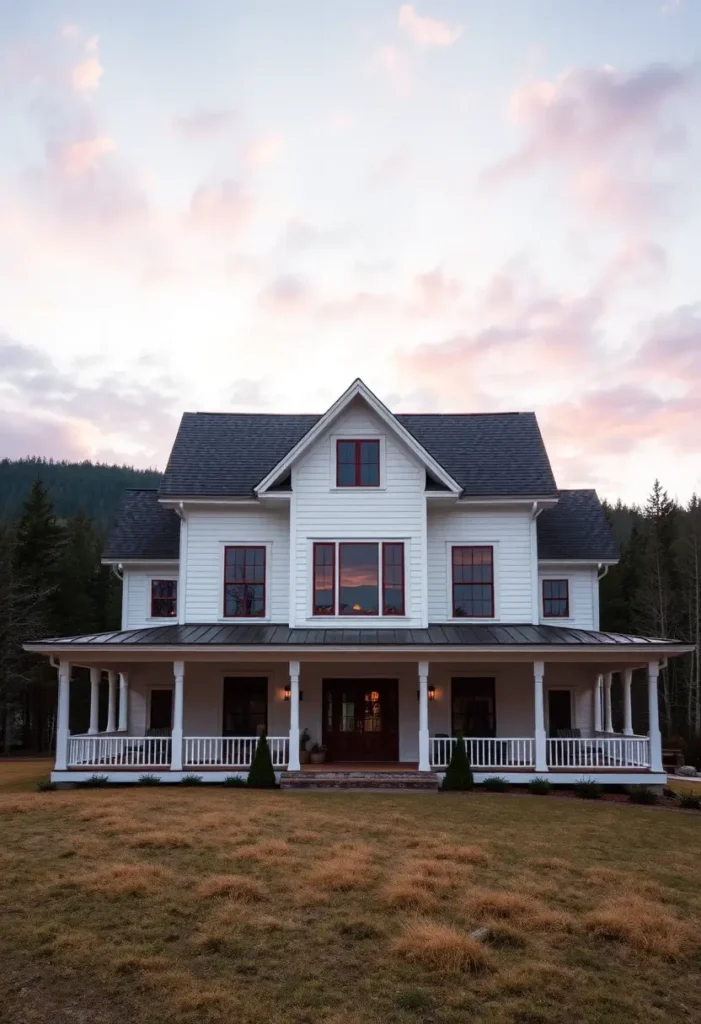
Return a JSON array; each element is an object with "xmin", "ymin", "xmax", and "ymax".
[{"xmin": 185, "ymin": 505, "xmax": 290, "ymax": 623}]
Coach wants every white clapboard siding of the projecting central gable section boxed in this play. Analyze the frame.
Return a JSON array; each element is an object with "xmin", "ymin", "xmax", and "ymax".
[{"xmin": 293, "ymin": 399, "xmax": 426, "ymax": 629}]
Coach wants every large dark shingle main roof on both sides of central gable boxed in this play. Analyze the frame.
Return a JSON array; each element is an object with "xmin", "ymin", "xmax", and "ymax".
[{"xmin": 160, "ymin": 413, "xmax": 557, "ymax": 498}]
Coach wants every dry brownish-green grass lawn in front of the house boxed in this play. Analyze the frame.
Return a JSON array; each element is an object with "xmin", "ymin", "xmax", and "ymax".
[{"xmin": 0, "ymin": 764, "xmax": 701, "ymax": 1024}]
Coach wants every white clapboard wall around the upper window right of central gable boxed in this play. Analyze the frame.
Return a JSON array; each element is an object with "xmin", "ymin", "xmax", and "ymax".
[{"xmin": 428, "ymin": 505, "xmax": 533, "ymax": 623}]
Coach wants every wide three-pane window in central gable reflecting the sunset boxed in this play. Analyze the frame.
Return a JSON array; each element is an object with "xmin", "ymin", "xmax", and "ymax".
[{"xmin": 312, "ymin": 541, "xmax": 405, "ymax": 615}]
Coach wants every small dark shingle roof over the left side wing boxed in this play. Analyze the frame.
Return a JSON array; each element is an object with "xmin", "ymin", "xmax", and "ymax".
[{"xmin": 102, "ymin": 488, "xmax": 180, "ymax": 561}]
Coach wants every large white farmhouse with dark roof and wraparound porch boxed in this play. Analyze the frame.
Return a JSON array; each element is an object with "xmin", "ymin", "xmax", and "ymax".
[{"xmin": 28, "ymin": 380, "xmax": 689, "ymax": 784}]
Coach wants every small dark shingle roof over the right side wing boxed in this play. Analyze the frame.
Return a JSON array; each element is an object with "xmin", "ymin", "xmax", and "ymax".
[{"xmin": 537, "ymin": 490, "xmax": 620, "ymax": 561}]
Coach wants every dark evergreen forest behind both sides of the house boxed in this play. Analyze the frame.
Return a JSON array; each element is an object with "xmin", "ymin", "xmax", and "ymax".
[{"xmin": 0, "ymin": 460, "xmax": 701, "ymax": 762}]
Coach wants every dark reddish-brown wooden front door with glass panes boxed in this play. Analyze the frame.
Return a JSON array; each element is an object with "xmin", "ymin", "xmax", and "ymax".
[{"xmin": 323, "ymin": 679, "xmax": 399, "ymax": 761}]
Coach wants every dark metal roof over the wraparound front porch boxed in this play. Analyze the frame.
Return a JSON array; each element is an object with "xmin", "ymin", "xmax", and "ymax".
[{"xmin": 32, "ymin": 623, "xmax": 691, "ymax": 649}]
